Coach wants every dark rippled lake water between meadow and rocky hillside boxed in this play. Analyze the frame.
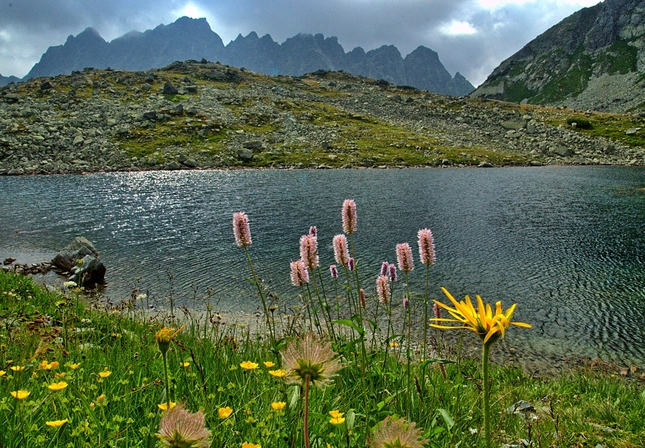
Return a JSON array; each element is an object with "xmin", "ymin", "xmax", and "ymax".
[{"xmin": 0, "ymin": 167, "xmax": 645, "ymax": 364}]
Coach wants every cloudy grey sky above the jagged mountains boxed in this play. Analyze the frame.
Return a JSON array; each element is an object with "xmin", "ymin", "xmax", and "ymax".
[{"xmin": 0, "ymin": 0, "xmax": 599, "ymax": 86}]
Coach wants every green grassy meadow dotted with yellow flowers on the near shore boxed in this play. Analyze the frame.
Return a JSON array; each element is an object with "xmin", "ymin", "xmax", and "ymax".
[{"xmin": 0, "ymin": 262, "xmax": 645, "ymax": 448}]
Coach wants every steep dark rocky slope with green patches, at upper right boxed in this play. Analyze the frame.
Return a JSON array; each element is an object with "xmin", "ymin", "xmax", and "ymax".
[{"xmin": 472, "ymin": 0, "xmax": 645, "ymax": 112}]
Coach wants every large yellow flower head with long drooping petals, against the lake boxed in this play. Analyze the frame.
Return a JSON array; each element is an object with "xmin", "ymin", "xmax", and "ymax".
[{"xmin": 430, "ymin": 288, "xmax": 531, "ymax": 344}]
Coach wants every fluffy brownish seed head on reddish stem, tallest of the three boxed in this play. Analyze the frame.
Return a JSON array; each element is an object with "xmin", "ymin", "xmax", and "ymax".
[{"xmin": 282, "ymin": 333, "xmax": 342, "ymax": 385}]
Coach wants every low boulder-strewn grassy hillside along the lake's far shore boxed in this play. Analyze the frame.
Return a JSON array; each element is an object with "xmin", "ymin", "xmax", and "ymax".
[{"xmin": 0, "ymin": 61, "xmax": 645, "ymax": 174}]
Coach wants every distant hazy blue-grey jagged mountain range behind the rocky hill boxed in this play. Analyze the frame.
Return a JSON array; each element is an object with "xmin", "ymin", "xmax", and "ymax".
[{"xmin": 10, "ymin": 17, "xmax": 475, "ymax": 96}]
